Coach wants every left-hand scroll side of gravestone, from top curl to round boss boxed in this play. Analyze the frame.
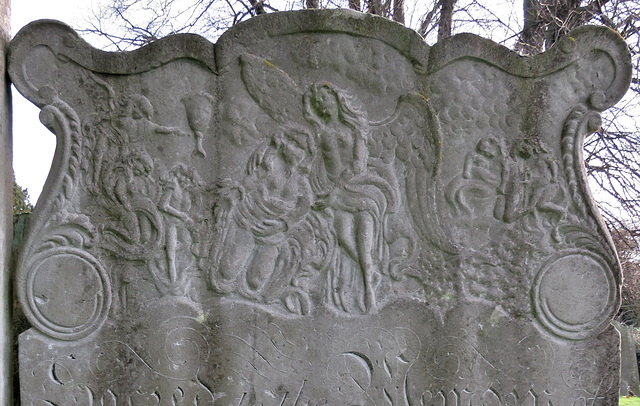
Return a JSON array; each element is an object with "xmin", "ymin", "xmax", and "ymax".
[{"xmin": 9, "ymin": 21, "xmax": 111, "ymax": 340}]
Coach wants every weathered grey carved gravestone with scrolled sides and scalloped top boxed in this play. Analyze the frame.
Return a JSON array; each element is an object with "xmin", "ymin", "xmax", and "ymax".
[{"xmin": 9, "ymin": 10, "xmax": 631, "ymax": 406}]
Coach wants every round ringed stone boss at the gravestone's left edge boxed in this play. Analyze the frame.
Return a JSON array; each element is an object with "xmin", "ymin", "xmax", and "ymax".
[{"xmin": 22, "ymin": 247, "xmax": 111, "ymax": 341}]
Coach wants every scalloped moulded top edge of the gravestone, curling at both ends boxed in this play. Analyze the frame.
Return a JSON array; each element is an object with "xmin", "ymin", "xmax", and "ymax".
[{"xmin": 9, "ymin": 9, "xmax": 632, "ymax": 109}]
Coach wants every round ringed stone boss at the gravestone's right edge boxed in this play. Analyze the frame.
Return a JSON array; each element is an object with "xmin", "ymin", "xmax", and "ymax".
[{"xmin": 531, "ymin": 249, "xmax": 617, "ymax": 340}]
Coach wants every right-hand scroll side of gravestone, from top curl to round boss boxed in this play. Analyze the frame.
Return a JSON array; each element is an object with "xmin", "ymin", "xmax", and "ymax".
[{"xmin": 532, "ymin": 27, "xmax": 632, "ymax": 340}]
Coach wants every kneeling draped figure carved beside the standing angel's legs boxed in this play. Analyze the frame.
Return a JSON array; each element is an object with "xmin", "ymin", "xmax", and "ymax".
[{"xmin": 209, "ymin": 131, "xmax": 320, "ymax": 314}]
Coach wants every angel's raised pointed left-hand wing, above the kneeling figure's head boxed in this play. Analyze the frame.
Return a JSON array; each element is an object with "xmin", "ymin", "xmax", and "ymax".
[{"xmin": 240, "ymin": 54, "xmax": 303, "ymax": 124}]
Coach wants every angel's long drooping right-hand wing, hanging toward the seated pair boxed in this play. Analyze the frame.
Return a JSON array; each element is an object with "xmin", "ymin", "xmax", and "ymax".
[{"xmin": 369, "ymin": 93, "xmax": 457, "ymax": 254}]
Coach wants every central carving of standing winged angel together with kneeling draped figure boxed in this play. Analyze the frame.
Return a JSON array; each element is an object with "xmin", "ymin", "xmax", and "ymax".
[{"xmin": 210, "ymin": 54, "xmax": 454, "ymax": 314}]
